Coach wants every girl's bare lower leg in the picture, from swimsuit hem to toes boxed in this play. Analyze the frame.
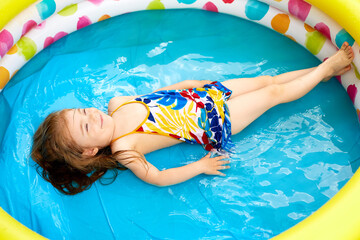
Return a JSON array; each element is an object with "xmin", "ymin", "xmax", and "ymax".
[{"xmin": 228, "ymin": 43, "xmax": 354, "ymax": 134}]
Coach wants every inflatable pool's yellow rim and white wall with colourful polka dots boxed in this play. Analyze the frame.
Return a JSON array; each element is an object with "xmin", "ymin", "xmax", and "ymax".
[{"xmin": 0, "ymin": 0, "xmax": 360, "ymax": 239}]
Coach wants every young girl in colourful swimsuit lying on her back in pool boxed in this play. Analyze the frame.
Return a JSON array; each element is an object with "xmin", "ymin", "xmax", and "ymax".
[{"xmin": 31, "ymin": 42, "xmax": 354, "ymax": 195}]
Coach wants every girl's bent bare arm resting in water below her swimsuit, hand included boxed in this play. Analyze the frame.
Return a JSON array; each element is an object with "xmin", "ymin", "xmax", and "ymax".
[{"xmin": 122, "ymin": 153, "xmax": 230, "ymax": 186}]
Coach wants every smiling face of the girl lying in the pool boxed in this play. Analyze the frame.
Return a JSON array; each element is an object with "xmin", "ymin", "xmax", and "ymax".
[{"xmin": 65, "ymin": 108, "xmax": 115, "ymax": 154}]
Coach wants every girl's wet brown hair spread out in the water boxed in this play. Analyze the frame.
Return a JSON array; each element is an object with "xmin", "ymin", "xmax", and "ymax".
[{"xmin": 31, "ymin": 109, "xmax": 144, "ymax": 195}]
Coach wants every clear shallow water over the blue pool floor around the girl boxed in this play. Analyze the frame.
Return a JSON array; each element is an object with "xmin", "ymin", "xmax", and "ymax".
[{"xmin": 0, "ymin": 10, "xmax": 360, "ymax": 239}]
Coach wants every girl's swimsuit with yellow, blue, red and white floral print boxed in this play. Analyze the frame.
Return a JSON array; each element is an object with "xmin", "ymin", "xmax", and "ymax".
[{"xmin": 111, "ymin": 82, "xmax": 234, "ymax": 152}]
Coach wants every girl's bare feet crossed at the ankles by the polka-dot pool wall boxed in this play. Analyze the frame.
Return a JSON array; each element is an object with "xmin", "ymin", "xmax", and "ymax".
[{"xmin": 321, "ymin": 42, "xmax": 354, "ymax": 82}]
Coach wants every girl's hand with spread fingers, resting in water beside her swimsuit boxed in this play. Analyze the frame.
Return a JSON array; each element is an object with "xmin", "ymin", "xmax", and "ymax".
[{"xmin": 198, "ymin": 152, "xmax": 230, "ymax": 176}]
